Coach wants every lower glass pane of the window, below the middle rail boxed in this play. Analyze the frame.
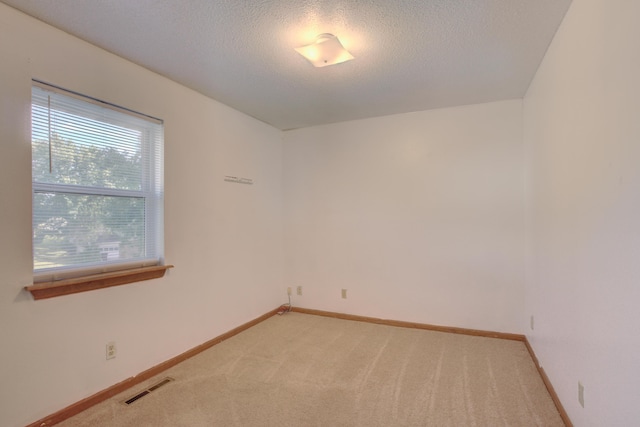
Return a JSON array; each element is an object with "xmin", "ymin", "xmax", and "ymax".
[{"xmin": 33, "ymin": 192, "xmax": 145, "ymax": 270}]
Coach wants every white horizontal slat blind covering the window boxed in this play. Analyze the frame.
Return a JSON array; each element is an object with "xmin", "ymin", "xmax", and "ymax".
[{"xmin": 31, "ymin": 81, "xmax": 163, "ymax": 281}]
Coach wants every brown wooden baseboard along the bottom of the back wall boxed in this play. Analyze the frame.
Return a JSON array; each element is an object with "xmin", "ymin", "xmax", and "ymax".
[{"xmin": 291, "ymin": 307, "xmax": 526, "ymax": 341}]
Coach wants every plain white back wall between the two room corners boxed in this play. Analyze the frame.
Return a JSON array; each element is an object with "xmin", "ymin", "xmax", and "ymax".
[{"xmin": 284, "ymin": 100, "xmax": 524, "ymax": 333}]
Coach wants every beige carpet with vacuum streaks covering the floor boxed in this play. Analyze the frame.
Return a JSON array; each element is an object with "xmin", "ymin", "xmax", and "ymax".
[{"xmin": 59, "ymin": 313, "xmax": 564, "ymax": 427}]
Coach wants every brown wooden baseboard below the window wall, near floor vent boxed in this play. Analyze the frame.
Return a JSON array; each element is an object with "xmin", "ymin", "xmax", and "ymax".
[{"xmin": 27, "ymin": 309, "xmax": 278, "ymax": 427}]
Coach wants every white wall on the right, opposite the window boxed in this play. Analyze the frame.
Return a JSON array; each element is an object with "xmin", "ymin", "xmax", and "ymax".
[{"xmin": 524, "ymin": 0, "xmax": 640, "ymax": 426}]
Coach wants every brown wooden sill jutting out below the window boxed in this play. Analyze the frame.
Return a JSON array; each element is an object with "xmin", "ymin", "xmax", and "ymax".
[{"xmin": 25, "ymin": 265, "xmax": 173, "ymax": 300}]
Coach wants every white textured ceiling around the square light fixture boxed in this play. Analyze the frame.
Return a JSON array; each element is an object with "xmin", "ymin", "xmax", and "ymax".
[{"xmin": 0, "ymin": 0, "xmax": 571, "ymax": 129}]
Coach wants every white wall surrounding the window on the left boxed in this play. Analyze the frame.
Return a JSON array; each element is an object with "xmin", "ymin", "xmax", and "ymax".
[{"xmin": 0, "ymin": 4, "xmax": 282, "ymax": 426}]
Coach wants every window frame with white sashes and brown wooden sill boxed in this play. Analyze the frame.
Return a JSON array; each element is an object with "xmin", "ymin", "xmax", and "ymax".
[{"xmin": 26, "ymin": 79, "xmax": 173, "ymax": 299}]
